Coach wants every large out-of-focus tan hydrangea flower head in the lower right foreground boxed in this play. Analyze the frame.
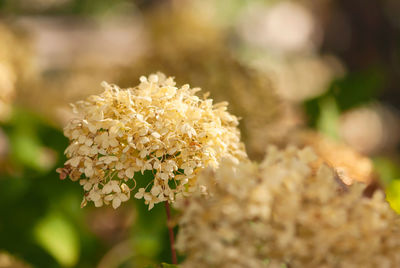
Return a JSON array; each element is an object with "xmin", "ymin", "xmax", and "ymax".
[{"xmin": 176, "ymin": 147, "xmax": 400, "ymax": 268}]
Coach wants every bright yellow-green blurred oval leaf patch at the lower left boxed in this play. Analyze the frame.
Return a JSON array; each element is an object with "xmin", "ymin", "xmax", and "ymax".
[{"xmin": 34, "ymin": 212, "xmax": 80, "ymax": 267}]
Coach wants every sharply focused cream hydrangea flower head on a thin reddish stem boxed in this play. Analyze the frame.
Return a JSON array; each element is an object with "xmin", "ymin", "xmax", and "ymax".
[{"xmin": 58, "ymin": 73, "xmax": 246, "ymax": 209}]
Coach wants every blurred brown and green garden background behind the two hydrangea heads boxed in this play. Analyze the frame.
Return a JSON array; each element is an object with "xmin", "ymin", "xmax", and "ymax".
[{"xmin": 0, "ymin": 0, "xmax": 400, "ymax": 268}]
